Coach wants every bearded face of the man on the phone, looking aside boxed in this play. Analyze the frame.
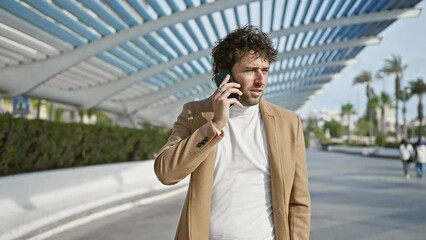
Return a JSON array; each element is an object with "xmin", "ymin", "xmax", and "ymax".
[{"xmin": 232, "ymin": 53, "xmax": 269, "ymax": 106}]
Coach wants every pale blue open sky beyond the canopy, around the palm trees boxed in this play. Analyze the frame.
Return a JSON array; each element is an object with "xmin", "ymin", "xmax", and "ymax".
[{"xmin": 297, "ymin": 1, "xmax": 426, "ymax": 120}]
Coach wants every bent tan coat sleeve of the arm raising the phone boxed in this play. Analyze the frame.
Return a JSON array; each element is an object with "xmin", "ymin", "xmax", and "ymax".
[{"xmin": 154, "ymin": 104, "xmax": 223, "ymax": 185}]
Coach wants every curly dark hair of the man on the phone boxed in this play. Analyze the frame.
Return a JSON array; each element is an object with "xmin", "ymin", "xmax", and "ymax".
[{"xmin": 211, "ymin": 25, "xmax": 278, "ymax": 74}]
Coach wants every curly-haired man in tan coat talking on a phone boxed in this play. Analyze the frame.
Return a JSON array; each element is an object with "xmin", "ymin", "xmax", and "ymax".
[{"xmin": 154, "ymin": 25, "xmax": 310, "ymax": 240}]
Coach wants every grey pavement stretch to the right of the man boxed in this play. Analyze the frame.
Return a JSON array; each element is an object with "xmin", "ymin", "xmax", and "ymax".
[{"xmin": 308, "ymin": 151, "xmax": 426, "ymax": 240}]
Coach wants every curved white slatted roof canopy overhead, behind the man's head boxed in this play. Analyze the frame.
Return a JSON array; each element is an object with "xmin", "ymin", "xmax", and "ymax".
[{"xmin": 0, "ymin": 0, "xmax": 421, "ymax": 126}]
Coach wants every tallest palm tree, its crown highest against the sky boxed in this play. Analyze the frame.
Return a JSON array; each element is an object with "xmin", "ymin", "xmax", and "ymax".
[{"xmin": 381, "ymin": 55, "xmax": 407, "ymax": 141}]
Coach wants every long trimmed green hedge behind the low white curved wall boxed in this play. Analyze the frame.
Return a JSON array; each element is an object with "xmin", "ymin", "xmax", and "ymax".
[{"xmin": 0, "ymin": 114, "xmax": 170, "ymax": 176}]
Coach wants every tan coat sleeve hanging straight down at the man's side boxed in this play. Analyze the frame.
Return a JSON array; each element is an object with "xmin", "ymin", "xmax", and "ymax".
[{"xmin": 288, "ymin": 118, "xmax": 311, "ymax": 240}]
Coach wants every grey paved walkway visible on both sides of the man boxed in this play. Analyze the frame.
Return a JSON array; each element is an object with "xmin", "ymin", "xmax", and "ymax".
[{"xmin": 46, "ymin": 150, "xmax": 426, "ymax": 240}]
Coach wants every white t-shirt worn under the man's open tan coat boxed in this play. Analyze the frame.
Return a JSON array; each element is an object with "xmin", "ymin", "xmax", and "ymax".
[{"xmin": 210, "ymin": 105, "xmax": 275, "ymax": 240}]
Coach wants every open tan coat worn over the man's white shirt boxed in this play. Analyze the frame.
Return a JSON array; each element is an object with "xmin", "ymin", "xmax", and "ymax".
[{"xmin": 154, "ymin": 98, "xmax": 311, "ymax": 240}]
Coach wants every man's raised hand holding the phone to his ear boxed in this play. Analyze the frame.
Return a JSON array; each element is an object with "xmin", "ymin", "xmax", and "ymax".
[{"xmin": 212, "ymin": 75, "xmax": 243, "ymax": 131}]
